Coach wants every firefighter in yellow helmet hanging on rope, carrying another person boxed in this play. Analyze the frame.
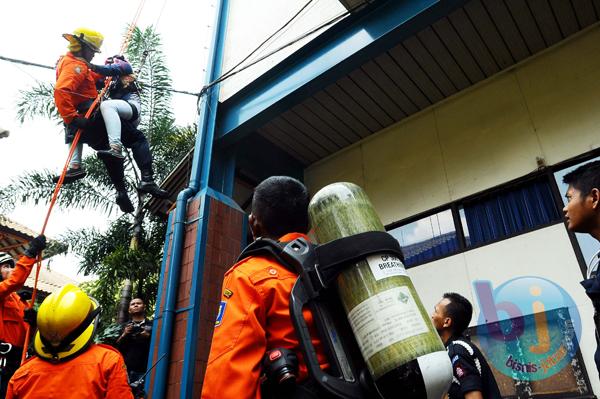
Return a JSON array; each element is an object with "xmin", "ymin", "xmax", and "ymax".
[{"xmin": 54, "ymin": 28, "xmax": 169, "ymax": 212}]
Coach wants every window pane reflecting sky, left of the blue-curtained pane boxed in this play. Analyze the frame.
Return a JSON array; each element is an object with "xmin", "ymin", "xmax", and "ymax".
[{"xmin": 388, "ymin": 209, "xmax": 459, "ymax": 267}]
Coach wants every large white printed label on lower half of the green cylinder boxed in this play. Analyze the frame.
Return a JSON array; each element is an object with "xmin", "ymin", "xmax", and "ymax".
[{"xmin": 348, "ymin": 286, "xmax": 429, "ymax": 360}]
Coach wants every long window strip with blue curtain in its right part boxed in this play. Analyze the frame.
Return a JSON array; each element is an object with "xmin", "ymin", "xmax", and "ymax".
[{"xmin": 388, "ymin": 174, "xmax": 561, "ymax": 267}]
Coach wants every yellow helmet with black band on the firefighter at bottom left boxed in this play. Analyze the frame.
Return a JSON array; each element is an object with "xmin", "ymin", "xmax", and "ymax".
[{"xmin": 33, "ymin": 284, "xmax": 100, "ymax": 361}]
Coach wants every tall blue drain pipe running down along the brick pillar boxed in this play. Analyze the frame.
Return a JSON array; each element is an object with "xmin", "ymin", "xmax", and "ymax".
[{"xmin": 152, "ymin": 0, "xmax": 227, "ymax": 399}]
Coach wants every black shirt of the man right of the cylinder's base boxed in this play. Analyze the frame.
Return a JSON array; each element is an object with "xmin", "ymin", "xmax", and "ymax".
[{"xmin": 446, "ymin": 337, "xmax": 502, "ymax": 399}]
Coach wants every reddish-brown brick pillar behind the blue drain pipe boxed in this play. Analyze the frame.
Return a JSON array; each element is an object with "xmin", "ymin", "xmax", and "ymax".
[{"xmin": 151, "ymin": 194, "xmax": 246, "ymax": 399}]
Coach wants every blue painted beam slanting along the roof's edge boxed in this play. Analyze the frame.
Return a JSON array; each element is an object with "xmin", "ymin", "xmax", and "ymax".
[{"xmin": 216, "ymin": 0, "xmax": 466, "ymax": 145}]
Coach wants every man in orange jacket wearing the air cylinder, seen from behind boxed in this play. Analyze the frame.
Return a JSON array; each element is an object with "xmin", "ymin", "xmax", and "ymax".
[{"xmin": 202, "ymin": 176, "xmax": 327, "ymax": 399}]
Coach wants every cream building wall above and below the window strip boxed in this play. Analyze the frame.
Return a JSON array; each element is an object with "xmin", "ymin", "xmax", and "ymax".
[{"xmin": 305, "ymin": 26, "xmax": 600, "ymax": 393}]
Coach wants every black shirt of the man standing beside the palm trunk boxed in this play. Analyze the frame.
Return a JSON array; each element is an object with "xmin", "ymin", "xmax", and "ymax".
[{"xmin": 117, "ymin": 319, "xmax": 152, "ymax": 373}]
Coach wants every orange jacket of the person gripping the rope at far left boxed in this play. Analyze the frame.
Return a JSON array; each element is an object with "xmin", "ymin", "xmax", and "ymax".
[{"xmin": 0, "ymin": 256, "xmax": 35, "ymax": 348}]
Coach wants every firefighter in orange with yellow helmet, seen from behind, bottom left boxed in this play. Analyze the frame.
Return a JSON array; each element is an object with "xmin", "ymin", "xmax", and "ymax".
[{"xmin": 6, "ymin": 284, "xmax": 133, "ymax": 399}]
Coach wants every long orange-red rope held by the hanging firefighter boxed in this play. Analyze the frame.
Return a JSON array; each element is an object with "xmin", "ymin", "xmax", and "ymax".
[{"xmin": 21, "ymin": 0, "xmax": 146, "ymax": 364}]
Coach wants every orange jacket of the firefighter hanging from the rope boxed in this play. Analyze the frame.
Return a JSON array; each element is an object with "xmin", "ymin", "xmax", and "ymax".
[{"xmin": 54, "ymin": 53, "xmax": 104, "ymax": 125}]
